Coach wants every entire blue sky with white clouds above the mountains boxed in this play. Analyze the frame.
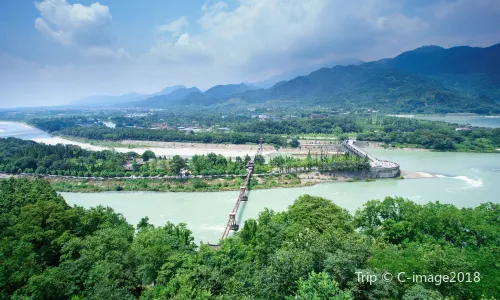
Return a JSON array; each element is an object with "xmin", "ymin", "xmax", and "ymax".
[{"xmin": 0, "ymin": 0, "xmax": 500, "ymax": 107}]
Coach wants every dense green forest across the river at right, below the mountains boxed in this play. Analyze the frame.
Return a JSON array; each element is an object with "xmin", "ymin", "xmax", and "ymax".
[{"xmin": 234, "ymin": 116, "xmax": 500, "ymax": 152}]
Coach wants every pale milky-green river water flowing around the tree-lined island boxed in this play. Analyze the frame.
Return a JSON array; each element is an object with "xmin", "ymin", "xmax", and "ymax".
[{"xmin": 0, "ymin": 122, "xmax": 500, "ymax": 243}]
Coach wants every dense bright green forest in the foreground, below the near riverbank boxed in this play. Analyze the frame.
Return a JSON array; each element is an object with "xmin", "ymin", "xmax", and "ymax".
[{"xmin": 0, "ymin": 179, "xmax": 500, "ymax": 300}]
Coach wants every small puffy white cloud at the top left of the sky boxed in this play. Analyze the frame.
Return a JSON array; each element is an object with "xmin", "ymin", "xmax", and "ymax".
[{"xmin": 35, "ymin": 0, "xmax": 129, "ymax": 58}]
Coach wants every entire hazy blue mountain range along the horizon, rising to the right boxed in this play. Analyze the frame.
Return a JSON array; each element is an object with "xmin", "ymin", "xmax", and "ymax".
[{"xmin": 73, "ymin": 44, "xmax": 500, "ymax": 114}]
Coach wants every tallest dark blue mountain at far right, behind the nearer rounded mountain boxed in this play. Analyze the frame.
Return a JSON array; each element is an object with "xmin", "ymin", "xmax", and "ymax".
[{"xmin": 374, "ymin": 44, "xmax": 500, "ymax": 102}]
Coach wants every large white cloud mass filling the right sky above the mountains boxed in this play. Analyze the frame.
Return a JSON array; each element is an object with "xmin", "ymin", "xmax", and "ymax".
[{"xmin": 149, "ymin": 0, "xmax": 500, "ymax": 82}]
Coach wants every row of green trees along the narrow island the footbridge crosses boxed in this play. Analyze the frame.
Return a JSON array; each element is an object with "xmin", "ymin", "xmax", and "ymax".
[{"xmin": 0, "ymin": 138, "xmax": 370, "ymax": 177}]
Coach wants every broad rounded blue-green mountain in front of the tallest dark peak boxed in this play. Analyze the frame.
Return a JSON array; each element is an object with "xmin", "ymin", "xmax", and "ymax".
[{"xmin": 234, "ymin": 64, "xmax": 500, "ymax": 113}]
